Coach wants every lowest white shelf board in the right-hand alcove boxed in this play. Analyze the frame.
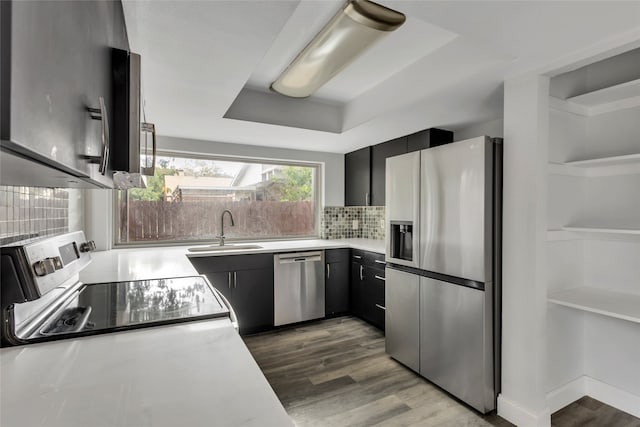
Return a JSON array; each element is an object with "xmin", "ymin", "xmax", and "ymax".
[{"xmin": 547, "ymin": 287, "xmax": 640, "ymax": 323}]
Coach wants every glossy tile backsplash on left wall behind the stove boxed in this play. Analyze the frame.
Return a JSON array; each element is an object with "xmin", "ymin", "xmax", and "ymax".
[{"xmin": 0, "ymin": 185, "xmax": 69, "ymax": 246}]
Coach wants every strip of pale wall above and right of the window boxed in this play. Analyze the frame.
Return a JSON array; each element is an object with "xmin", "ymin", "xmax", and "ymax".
[{"xmin": 158, "ymin": 136, "xmax": 344, "ymax": 206}]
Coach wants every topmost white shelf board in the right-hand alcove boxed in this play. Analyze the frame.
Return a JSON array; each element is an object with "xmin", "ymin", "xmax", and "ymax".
[{"xmin": 567, "ymin": 79, "xmax": 640, "ymax": 114}]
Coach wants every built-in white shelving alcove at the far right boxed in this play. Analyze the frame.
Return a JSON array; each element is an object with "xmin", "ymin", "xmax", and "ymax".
[{"xmin": 544, "ymin": 56, "xmax": 640, "ymax": 418}]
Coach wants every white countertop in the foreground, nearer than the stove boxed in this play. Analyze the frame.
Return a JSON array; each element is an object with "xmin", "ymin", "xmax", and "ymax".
[{"xmin": 0, "ymin": 320, "xmax": 293, "ymax": 427}]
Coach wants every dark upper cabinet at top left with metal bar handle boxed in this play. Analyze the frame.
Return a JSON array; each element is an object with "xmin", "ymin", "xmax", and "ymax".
[{"xmin": 0, "ymin": 1, "xmax": 129, "ymax": 187}]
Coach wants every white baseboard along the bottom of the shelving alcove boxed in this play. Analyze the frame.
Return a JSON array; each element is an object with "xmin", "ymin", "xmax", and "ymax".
[{"xmin": 544, "ymin": 375, "xmax": 640, "ymax": 417}]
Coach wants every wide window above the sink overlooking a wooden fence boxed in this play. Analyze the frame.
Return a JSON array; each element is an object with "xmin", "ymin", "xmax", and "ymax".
[{"xmin": 115, "ymin": 153, "xmax": 319, "ymax": 245}]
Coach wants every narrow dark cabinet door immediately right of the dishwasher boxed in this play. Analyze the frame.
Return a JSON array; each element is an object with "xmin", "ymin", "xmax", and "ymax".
[{"xmin": 324, "ymin": 249, "xmax": 350, "ymax": 316}]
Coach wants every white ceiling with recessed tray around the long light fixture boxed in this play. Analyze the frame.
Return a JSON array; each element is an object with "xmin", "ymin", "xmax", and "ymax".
[{"xmin": 124, "ymin": 0, "xmax": 640, "ymax": 153}]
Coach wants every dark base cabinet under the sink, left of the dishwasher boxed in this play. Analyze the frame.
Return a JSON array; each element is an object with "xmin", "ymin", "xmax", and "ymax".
[{"xmin": 189, "ymin": 254, "xmax": 273, "ymax": 334}]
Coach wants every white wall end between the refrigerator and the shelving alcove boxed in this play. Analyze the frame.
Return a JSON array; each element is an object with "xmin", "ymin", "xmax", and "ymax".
[{"xmin": 498, "ymin": 76, "xmax": 551, "ymax": 426}]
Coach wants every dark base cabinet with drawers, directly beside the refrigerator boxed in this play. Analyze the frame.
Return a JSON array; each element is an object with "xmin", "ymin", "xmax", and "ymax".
[{"xmin": 350, "ymin": 249, "xmax": 385, "ymax": 331}]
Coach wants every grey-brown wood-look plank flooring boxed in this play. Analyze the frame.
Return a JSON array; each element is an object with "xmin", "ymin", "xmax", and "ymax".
[{"xmin": 244, "ymin": 316, "xmax": 640, "ymax": 427}]
